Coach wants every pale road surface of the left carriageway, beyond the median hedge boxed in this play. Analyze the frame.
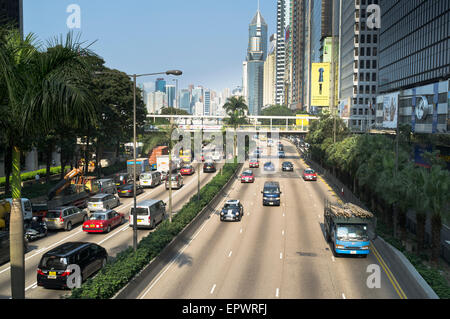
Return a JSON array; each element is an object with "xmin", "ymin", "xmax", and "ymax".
[{"xmin": 0, "ymin": 164, "xmax": 222, "ymax": 299}]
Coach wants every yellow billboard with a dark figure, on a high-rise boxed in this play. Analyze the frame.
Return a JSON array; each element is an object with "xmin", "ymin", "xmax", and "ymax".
[{"xmin": 311, "ymin": 63, "xmax": 331, "ymax": 107}]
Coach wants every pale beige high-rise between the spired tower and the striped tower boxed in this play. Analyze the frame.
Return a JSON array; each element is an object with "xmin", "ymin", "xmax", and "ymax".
[{"xmin": 263, "ymin": 34, "xmax": 278, "ymax": 107}]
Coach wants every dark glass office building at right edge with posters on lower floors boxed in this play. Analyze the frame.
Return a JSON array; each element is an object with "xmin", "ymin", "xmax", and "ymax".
[{"xmin": 376, "ymin": 0, "xmax": 450, "ymax": 133}]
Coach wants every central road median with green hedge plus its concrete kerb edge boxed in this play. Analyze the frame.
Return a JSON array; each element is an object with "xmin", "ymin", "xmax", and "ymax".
[{"xmin": 68, "ymin": 164, "xmax": 240, "ymax": 299}]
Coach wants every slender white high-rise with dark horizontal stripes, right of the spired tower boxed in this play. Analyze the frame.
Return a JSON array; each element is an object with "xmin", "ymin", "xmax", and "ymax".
[{"xmin": 275, "ymin": 0, "xmax": 292, "ymax": 105}]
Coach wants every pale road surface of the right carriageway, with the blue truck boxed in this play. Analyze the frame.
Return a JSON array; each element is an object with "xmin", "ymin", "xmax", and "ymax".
[{"xmin": 138, "ymin": 140, "xmax": 401, "ymax": 299}]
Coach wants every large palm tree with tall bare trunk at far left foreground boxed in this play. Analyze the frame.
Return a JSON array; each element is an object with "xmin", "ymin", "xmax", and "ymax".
[{"xmin": 0, "ymin": 29, "xmax": 96, "ymax": 298}]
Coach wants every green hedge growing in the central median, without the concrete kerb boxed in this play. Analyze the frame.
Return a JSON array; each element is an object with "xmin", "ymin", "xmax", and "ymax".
[{"xmin": 69, "ymin": 164, "xmax": 238, "ymax": 299}]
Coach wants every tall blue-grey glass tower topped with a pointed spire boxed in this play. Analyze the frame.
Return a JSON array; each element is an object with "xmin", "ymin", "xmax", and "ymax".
[{"xmin": 247, "ymin": 1, "xmax": 268, "ymax": 115}]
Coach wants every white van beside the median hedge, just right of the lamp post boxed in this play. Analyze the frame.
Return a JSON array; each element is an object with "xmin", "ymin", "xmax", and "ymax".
[{"xmin": 129, "ymin": 199, "xmax": 166, "ymax": 229}]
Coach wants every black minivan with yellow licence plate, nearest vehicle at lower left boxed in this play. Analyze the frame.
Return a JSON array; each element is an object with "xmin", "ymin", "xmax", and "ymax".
[{"xmin": 37, "ymin": 242, "xmax": 108, "ymax": 289}]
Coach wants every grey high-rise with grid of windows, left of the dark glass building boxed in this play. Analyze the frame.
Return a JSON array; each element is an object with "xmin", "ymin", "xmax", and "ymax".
[{"xmin": 339, "ymin": 0, "xmax": 380, "ymax": 131}]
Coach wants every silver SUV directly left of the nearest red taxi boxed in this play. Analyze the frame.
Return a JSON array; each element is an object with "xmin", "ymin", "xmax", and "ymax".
[{"xmin": 44, "ymin": 206, "xmax": 88, "ymax": 231}]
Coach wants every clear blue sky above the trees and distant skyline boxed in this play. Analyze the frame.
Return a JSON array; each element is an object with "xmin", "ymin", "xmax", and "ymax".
[{"xmin": 23, "ymin": 0, "xmax": 276, "ymax": 91}]
